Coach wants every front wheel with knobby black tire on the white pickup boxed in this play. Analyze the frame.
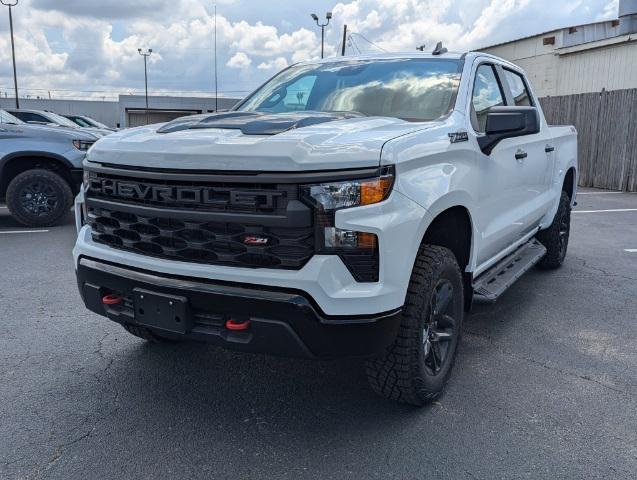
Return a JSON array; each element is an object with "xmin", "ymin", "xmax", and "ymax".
[{"xmin": 366, "ymin": 245, "xmax": 464, "ymax": 406}]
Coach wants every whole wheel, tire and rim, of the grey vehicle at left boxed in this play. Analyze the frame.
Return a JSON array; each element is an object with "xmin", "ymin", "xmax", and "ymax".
[{"xmin": 7, "ymin": 169, "xmax": 73, "ymax": 227}]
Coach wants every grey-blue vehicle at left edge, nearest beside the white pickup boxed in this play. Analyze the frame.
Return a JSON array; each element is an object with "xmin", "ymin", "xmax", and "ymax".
[{"xmin": 0, "ymin": 110, "xmax": 97, "ymax": 227}]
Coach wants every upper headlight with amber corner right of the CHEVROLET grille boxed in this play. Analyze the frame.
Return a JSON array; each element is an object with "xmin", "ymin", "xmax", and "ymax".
[{"xmin": 305, "ymin": 166, "xmax": 394, "ymax": 212}]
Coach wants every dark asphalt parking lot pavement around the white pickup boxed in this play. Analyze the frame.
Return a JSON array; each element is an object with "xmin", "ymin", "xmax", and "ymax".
[{"xmin": 0, "ymin": 190, "xmax": 637, "ymax": 480}]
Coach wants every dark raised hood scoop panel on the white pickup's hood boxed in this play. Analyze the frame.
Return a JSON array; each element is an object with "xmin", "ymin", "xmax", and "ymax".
[{"xmin": 157, "ymin": 111, "xmax": 363, "ymax": 135}]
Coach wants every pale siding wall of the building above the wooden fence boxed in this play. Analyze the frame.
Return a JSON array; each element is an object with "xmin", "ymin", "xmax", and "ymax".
[{"xmin": 481, "ymin": 30, "xmax": 637, "ymax": 97}]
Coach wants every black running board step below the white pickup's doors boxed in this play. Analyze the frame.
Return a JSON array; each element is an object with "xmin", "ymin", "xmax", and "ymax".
[{"xmin": 473, "ymin": 238, "xmax": 546, "ymax": 302}]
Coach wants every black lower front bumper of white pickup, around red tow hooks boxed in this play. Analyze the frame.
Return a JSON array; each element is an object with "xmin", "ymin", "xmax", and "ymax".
[{"xmin": 77, "ymin": 257, "xmax": 400, "ymax": 358}]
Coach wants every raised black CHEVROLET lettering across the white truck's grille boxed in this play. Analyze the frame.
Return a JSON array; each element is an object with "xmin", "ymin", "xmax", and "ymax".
[{"xmin": 88, "ymin": 178, "xmax": 285, "ymax": 208}]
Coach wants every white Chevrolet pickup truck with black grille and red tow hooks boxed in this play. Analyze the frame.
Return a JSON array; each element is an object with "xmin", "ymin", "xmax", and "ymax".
[{"xmin": 73, "ymin": 50, "xmax": 577, "ymax": 405}]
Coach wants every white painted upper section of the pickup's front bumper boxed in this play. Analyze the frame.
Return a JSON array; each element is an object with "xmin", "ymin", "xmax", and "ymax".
[{"xmin": 73, "ymin": 191, "xmax": 430, "ymax": 318}]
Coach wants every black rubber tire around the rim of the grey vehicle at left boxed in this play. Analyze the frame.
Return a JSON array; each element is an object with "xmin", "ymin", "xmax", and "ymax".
[{"xmin": 6, "ymin": 168, "xmax": 73, "ymax": 227}]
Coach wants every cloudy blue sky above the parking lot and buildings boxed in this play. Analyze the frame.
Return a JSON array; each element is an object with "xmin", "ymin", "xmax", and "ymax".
[{"xmin": 0, "ymin": 0, "xmax": 618, "ymax": 98}]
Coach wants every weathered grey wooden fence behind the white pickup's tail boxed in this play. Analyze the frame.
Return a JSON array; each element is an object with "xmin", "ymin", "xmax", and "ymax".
[{"xmin": 540, "ymin": 88, "xmax": 637, "ymax": 192}]
